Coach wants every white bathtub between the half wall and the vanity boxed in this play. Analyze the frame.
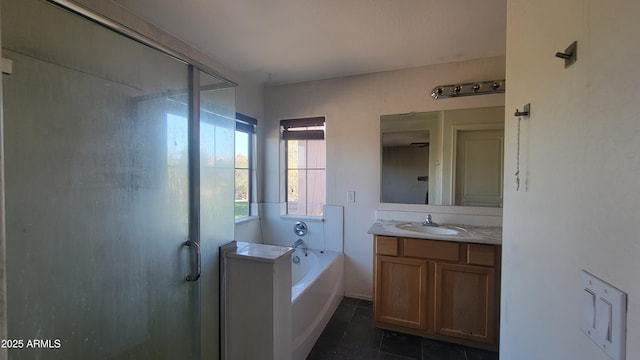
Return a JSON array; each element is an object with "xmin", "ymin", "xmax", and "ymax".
[{"xmin": 291, "ymin": 248, "xmax": 344, "ymax": 360}]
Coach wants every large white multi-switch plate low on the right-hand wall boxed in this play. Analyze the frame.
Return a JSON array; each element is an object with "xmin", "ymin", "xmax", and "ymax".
[{"xmin": 580, "ymin": 270, "xmax": 627, "ymax": 360}]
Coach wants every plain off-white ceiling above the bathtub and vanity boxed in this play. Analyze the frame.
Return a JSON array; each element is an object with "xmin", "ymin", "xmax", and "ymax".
[{"xmin": 114, "ymin": 0, "xmax": 507, "ymax": 85}]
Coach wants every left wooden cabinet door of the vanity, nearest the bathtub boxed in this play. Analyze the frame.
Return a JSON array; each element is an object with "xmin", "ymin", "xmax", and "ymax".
[{"xmin": 373, "ymin": 256, "xmax": 428, "ymax": 330}]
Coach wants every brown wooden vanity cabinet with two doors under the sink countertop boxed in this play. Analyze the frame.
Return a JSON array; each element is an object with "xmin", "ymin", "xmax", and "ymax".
[{"xmin": 373, "ymin": 235, "xmax": 501, "ymax": 350}]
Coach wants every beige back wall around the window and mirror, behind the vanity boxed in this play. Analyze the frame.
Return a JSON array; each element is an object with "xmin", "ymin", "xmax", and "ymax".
[{"xmin": 263, "ymin": 57, "xmax": 509, "ymax": 298}]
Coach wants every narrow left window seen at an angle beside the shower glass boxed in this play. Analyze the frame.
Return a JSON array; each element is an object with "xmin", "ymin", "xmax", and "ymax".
[{"xmin": 234, "ymin": 113, "xmax": 258, "ymax": 219}]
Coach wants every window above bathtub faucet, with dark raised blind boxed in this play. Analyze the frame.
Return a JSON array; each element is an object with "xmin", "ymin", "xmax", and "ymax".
[{"xmin": 280, "ymin": 117, "xmax": 326, "ymax": 216}]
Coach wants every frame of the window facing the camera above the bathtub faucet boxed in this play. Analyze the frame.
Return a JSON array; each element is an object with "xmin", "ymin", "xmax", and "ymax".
[{"xmin": 280, "ymin": 116, "xmax": 327, "ymax": 218}]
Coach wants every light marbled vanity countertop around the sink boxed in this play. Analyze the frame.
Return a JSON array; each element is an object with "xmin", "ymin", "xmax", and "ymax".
[{"xmin": 369, "ymin": 220, "xmax": 502, "ymax": 245}]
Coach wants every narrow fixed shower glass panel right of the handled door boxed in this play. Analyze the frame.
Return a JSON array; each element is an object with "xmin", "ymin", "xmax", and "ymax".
[{"xmin": 199, "ymin": 73, "xmax": 236, "ymax": 358}]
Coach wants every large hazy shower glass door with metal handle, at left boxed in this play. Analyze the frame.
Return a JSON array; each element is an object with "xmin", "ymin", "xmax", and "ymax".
[{"xmin": 1, "ymin": 0, "xmax": 199, "ymax": 359}]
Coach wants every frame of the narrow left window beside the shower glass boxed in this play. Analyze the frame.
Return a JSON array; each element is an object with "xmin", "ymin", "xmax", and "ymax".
[{"xmin": 233, "ymin": 112, "xmax": 258, "ymax": 222}]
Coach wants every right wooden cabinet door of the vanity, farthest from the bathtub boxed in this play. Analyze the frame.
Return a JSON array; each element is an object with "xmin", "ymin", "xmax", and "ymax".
[{"xmin": 435, "ymin": 262, "xmax": 496, "ymax": 344}]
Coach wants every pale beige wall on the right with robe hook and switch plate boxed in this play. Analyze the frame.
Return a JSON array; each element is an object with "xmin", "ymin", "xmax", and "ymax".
[{"xmin": 500, "ymin": 0, "xmax": 640, "ymax": 360}]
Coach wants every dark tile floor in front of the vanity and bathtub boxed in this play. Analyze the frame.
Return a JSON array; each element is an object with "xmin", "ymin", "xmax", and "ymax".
[{"xmin": 307, "ymin": 297, "xmax": 498, "ymax": 360}]
